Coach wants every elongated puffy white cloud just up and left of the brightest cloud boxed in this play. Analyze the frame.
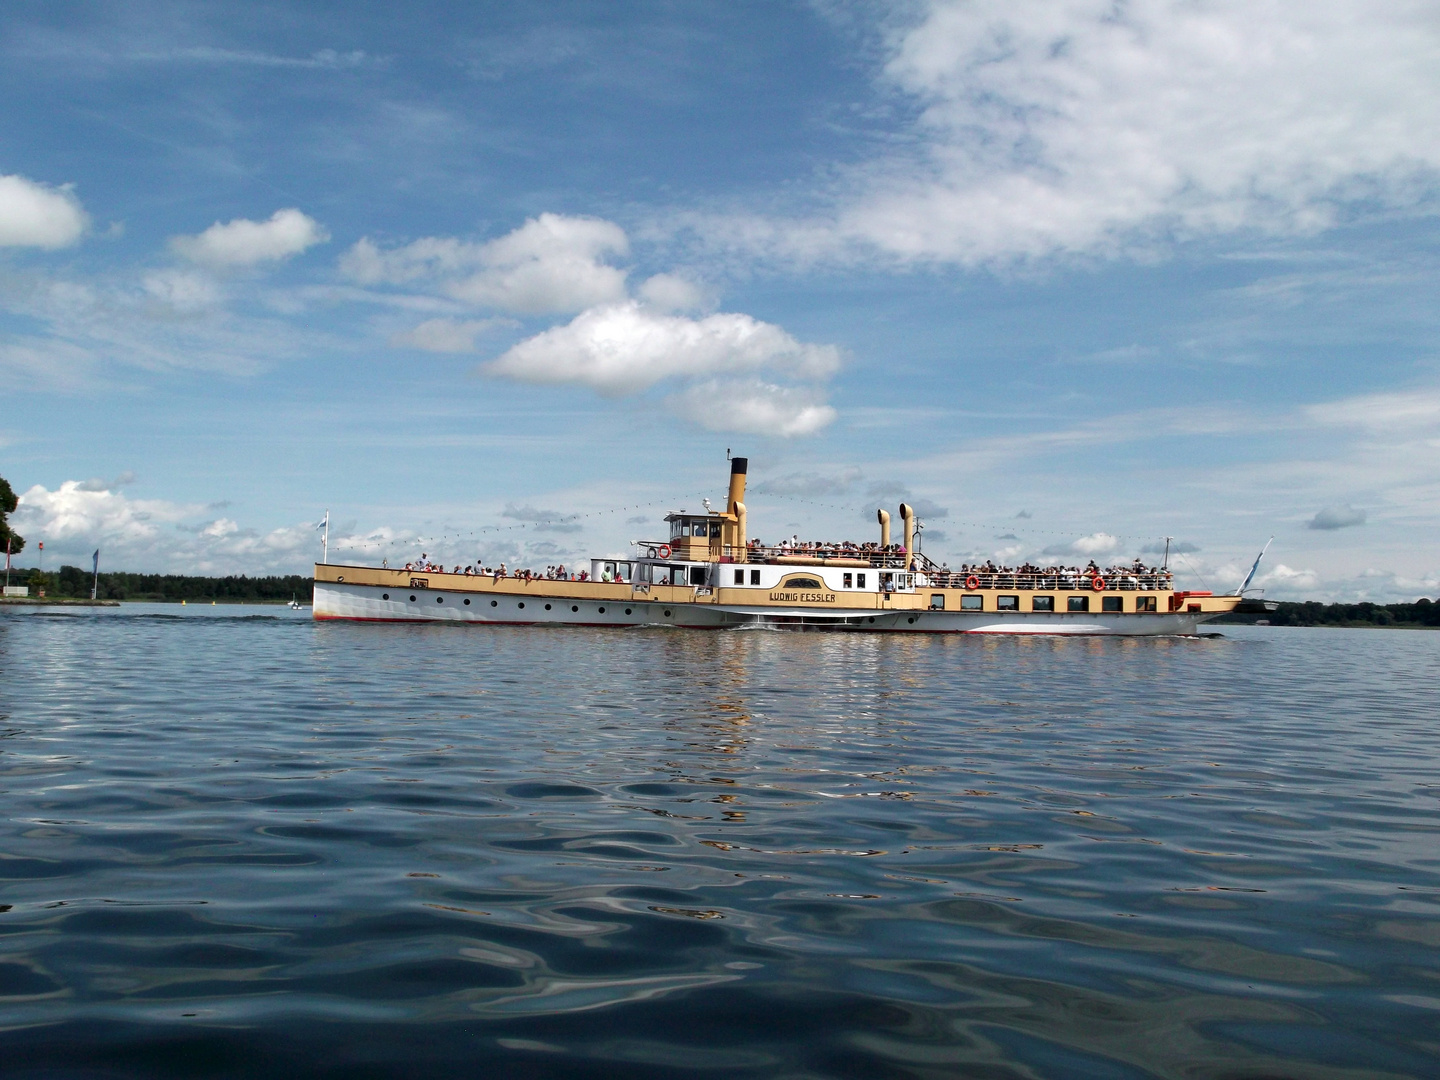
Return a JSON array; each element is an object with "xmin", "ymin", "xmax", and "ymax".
[{"xmin": 340, "ymin": 213, "xmax": 629, "ymax": 315}]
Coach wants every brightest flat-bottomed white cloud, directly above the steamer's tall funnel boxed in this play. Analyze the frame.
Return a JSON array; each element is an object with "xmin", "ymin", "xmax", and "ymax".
[{"xmin": 488, "ymin": 301, "xmax": 840, "ymax": 395}]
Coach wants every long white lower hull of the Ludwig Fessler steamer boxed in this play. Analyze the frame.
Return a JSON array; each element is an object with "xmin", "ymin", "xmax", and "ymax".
[{"xmin": 314, "ymin": 582, "xmax": 1223, "ymax": 636}]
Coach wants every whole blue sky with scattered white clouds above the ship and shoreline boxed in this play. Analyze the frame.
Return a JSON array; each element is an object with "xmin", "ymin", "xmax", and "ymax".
[{"xmin": 0, "ymin": 0, "xmax": 1440, "ymax": 599}]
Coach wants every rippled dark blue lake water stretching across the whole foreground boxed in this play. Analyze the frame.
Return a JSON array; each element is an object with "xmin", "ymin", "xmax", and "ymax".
[{"xmin": 0, "ymin": 605, "xmax": 1440, "ymax": 1080}]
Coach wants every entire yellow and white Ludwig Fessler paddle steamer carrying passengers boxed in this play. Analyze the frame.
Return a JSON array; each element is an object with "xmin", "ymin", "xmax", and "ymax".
[{"xmin": 312, "ymin": 458, "xmax": 1263, "ymax": 635}]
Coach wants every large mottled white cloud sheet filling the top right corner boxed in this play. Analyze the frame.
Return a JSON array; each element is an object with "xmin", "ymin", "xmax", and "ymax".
[{"xmin": 717, "ymin": 0, "xmax": 1440, "ymax": 265}]
